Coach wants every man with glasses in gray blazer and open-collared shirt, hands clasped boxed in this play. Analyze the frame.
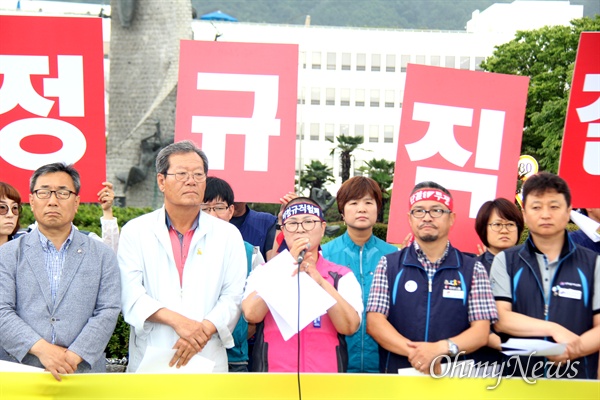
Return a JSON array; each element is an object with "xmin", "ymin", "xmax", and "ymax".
[{"xmin": 0, "ymin": 163, "xmax": 120, "ymax": 381}]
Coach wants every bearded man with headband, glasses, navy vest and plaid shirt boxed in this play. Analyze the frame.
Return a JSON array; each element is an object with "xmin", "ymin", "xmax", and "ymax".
[{"xmin": 367, "ymin": 182, "xmax": 498, "ymax": 374}]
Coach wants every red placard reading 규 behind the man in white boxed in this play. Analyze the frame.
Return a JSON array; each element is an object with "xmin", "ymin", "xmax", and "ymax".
[{"xmin": 175, "ymin": 41, "xmax": 298, "ymax": 203}]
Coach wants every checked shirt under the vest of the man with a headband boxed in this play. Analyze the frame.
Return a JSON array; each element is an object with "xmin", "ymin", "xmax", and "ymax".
[{"xmin": 367, "ymin": 241, "xmax": 498, "ymax": 324}]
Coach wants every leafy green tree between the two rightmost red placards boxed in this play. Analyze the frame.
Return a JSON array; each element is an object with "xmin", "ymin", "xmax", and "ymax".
[{"xmin": 481, "ymin": 15, "xmax": 600, "ymax": 172}]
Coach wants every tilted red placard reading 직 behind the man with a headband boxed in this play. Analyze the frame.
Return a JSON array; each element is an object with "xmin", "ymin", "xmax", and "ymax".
[{"xmin": 387, "ymin": 64, "xmax": 529, "ymax": 253}]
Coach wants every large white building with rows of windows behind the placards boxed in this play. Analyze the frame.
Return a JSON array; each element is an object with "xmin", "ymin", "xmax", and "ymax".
[{"xmin": 0, "ymin": 0, "xmax": 583, "ymax": 192}]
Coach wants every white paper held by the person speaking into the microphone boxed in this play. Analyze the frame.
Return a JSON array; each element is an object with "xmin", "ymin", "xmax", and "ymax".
[{"xmin": 254, "ymin": 250, "xmax": 336, "ymax": 340}]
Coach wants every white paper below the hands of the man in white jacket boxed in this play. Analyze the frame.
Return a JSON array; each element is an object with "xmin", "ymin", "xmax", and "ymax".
[{"xmin": 136, "ymin": 346, "xmax": 215, "ymax": 374}]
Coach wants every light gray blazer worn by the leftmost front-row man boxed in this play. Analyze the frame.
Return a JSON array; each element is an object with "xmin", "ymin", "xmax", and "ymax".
[{"xmin": 0, "ymin": 230, "xmax": 121, "ymax": 372}]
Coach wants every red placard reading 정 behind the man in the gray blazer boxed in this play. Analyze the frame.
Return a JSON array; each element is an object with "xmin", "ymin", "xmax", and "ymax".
[{"xmin": 0, "ymin": 16, "xmax": 106, "ymax": 202}]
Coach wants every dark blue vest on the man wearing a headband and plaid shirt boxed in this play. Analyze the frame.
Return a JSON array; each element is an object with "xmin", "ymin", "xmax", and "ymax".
[{"xmin": 379, "ymin": 246, "xmax": 475, "ymax": 374}]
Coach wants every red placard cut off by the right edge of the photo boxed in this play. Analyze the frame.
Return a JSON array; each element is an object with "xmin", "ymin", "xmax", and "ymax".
[{"xmin": 558, "ymin": 32, "xmax": 600, "ymax": 208}]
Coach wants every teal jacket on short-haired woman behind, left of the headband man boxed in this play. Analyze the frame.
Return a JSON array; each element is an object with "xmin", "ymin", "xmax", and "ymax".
[{"xmin": 322, "ymin": 232, "xmax": 398, "ymax": 373}]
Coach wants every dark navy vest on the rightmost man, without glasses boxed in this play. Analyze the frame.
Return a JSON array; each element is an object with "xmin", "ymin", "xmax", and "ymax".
[{"xmin": 500, "ymin": 233, "xmax": 598, "ymax": 379}]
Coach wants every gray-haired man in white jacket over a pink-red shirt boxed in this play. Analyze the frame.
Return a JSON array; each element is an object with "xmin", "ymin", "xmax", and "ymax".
[{"xmin": 118, "ymin": 141, "xmax": 246, "ymax": 372}]
